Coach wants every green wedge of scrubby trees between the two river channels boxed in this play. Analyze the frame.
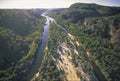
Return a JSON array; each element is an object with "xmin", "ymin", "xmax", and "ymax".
[{"xmin": 32, "ymin": 23, "xmax": 96, "ymax": 81}]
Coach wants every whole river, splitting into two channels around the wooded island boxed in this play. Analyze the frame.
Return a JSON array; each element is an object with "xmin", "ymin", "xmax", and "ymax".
[{"xmin": 28, "ymin": 13, "xmax": 106, "ymax": 81}]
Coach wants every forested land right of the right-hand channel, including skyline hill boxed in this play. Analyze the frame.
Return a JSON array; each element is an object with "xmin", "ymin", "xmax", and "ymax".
[{"xmin": 48, "ymin": 3, "xmax": 120, "ymax": 81}]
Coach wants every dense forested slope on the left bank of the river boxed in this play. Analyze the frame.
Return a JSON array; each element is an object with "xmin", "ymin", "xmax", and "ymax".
[{"xmin": 0, "ymin": 9, "xmax": 45, "ymax": 81}]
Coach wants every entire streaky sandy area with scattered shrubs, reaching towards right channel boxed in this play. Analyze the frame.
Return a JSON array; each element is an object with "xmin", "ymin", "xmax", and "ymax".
[{"xmin": 52, "ymin": 34, "xmax": 97, "ymax": 81}]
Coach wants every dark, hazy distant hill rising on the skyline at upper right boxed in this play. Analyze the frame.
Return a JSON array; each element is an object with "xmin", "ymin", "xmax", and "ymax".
[{"xmin": 49, "ymin": 3, "xmax": 120, "ymax": 23}]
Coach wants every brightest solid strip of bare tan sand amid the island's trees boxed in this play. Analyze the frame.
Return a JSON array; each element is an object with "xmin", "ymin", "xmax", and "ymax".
[{"xmin": 57, "ymin": 43, "xmax": 80, "ymax": 81}]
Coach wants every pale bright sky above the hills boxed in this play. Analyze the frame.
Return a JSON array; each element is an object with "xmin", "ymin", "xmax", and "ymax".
[{"xmin": 0, "ymin": 0, "xmax": 120, "ymax": 9}]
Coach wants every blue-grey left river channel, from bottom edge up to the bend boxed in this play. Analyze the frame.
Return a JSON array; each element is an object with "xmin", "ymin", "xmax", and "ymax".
[{"xmin": 27, "ymin": 13, "xmax": 50, "ymax": 81}]
